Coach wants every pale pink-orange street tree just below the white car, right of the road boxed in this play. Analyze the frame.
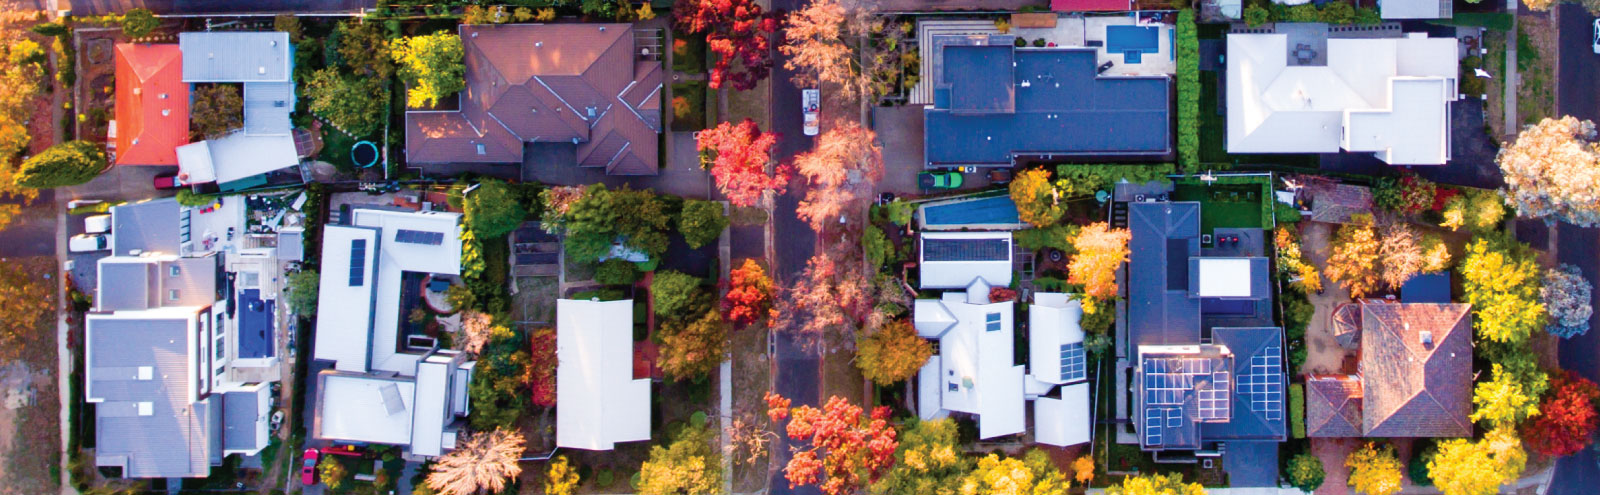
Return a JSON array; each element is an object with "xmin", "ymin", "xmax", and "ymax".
[{"xmin": 794, "ymin": 122, "xmax": 883, "ymax": 232}]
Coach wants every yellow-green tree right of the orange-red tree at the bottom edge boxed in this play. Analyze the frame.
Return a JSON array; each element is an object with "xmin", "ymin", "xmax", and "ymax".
[{"xmin": 869, "ymin": 418, "xmax": 973, "ymax": 495}]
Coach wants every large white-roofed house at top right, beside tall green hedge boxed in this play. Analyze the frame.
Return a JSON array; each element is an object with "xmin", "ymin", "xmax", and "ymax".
[{"xmin": 1226, "ymin": 31, "xmax": 1459, "ymax": 165}]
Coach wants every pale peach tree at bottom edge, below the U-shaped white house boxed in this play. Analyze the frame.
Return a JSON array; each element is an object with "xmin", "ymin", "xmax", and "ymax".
[{"xmin": 427, "ymin": 429, "xmax": 523, "ymax": 495}]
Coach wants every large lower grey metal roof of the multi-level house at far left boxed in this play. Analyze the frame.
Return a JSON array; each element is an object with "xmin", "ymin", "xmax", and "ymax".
[{"xmin": 85, "ymin": 317, "xmax": 218, "ymax": 477}]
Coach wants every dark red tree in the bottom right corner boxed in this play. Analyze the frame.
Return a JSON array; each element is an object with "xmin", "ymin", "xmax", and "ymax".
[{"xmin": 1522, "ymin": 372, "xmax": 1600, "ymax": 457}]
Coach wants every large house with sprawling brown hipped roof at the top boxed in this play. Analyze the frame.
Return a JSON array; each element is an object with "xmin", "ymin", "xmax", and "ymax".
[{"xmin": 406, "ymin": 24, "xmax": 662, "ymax": 175}]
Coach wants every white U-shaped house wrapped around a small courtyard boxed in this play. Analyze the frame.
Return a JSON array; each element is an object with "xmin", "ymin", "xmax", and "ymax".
[{"xmin": 312, "ymin": 207, "xmax": 475, "ymax": 458}]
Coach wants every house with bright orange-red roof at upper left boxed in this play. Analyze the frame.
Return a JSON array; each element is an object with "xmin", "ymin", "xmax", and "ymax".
[{"xmin": 112, "ymin": 43, "xmax": 189, "ymax": 165}]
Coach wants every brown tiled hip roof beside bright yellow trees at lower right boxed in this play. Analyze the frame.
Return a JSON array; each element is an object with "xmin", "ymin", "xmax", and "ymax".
[{"xmin": 1360, "ymin": 303, "xmax": 1472, "ymax": 437}]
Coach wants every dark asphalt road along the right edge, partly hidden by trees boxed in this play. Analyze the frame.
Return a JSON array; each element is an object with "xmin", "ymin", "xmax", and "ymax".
[{"xmin": 1549, "ymin": 3, "xmax": 1600, "ymax": 495}]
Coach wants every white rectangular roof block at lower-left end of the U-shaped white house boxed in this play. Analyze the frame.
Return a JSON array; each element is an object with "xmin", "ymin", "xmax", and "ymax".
[{"xmin": 317, "ymin": 373, "xmax": 416, "ymax": 445}]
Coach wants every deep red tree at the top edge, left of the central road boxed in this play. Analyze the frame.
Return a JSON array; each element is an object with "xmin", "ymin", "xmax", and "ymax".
[{"xmin": 672, "ymin": 0, "xmax": 778, "ymax": 91}]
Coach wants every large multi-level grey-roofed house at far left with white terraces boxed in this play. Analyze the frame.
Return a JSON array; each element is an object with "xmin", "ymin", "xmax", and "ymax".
[{"xmin": 83, "ymin": 199, "xmax": 282, "ymax": 477}]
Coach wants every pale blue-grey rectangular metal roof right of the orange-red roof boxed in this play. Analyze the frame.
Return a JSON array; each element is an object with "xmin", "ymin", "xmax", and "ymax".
[{"xmin": 178, "ymin": 30, "xmax": 291, "ymax": 83}]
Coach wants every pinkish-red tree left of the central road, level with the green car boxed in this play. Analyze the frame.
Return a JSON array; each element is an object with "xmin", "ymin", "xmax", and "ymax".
[{"xmin": 694, "ymin": 119, "xmax": 789, "ymax": 207}]
